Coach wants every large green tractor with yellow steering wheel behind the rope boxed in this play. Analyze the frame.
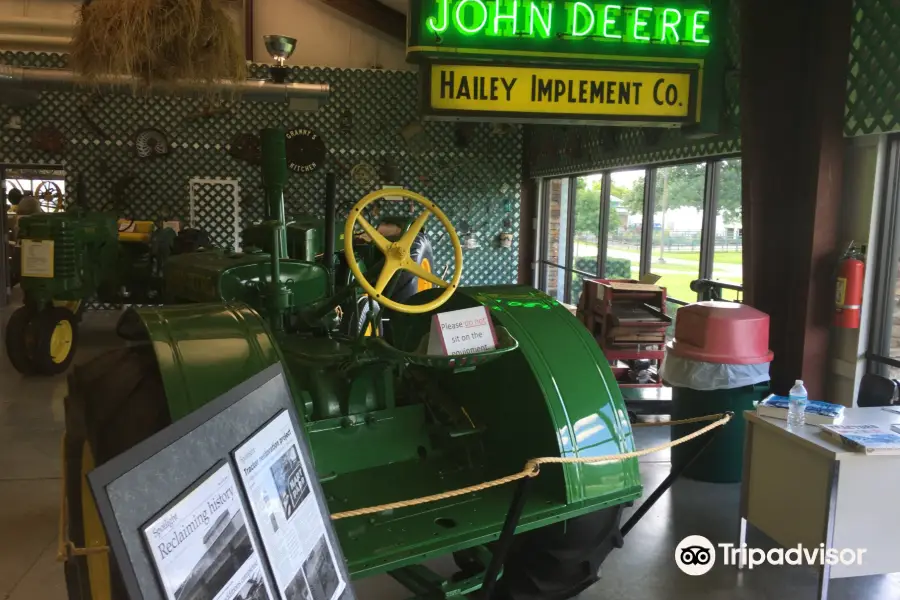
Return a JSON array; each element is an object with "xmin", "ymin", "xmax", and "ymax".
[{"xmin": 64, "ymin": 129, "xmax": 642, "ymax": 600}]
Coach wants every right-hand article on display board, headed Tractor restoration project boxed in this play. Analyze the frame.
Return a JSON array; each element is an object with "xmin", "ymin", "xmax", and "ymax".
[{"xmin": 235, "ymin": 411, "xmax": 347, "ymax": 600}]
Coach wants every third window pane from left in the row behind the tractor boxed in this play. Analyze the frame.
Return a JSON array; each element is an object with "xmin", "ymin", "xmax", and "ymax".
[{"xmin": 603, "ymin": 169, "xmax": 647, "ymax": 279}]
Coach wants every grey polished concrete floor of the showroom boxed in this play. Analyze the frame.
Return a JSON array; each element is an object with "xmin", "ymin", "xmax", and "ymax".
[{"xmin": 0, "ymin": 302, "xmax": 900, "ymax": 600}]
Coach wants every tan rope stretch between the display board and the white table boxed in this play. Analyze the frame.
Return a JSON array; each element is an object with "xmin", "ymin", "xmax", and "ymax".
[{"xmin": 331, "ymin": 413, "xmax": 732, "ymax": 521}]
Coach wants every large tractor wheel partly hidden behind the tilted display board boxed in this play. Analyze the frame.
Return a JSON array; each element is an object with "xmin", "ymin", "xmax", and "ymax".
[{"xmin": 63, "ymin": 344, "xmax": 171, "ymax": 600}]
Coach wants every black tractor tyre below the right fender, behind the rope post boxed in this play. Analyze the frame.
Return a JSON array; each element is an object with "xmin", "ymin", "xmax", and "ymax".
[{"xmin": 493, "ymin": 505, "xmax": 624, "ymax": 600}]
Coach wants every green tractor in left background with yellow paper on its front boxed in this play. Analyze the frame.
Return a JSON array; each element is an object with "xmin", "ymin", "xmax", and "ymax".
[{"xmin": 5, "ymin": 208, "xmax": 187, "ymax": 375}]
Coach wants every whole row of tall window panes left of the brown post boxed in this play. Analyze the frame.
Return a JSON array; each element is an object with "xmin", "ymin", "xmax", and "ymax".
[{"xmin": 537, "ymin": 158, "xmax": 744, "ymax": 310}]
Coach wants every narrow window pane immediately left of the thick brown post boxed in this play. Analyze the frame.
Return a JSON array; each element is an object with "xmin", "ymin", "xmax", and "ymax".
[{"xmin": 712, "ymin": 158, "xmax": 744, "ymax": 300}]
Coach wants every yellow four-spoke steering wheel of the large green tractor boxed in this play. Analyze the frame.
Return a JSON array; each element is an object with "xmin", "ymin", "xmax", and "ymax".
[{"xmin": 344, "ymin": 188, "xmax": 462, "ymax": 314}]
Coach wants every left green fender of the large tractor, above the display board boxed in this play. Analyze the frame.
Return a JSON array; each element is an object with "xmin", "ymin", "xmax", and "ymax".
[{"xmin": 136, "ymin": 302, "xmax": 281, "ymax": 421}]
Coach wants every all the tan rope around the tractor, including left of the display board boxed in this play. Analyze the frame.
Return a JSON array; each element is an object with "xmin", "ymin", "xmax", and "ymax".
[{"xmin": 57, "ymin": 413, "xmax": 732, "ymax": 561}]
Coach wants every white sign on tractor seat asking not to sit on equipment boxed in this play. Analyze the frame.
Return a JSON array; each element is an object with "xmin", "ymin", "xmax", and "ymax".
[{"xmin": 428, "ymin": 306, "xmax": 497, "ymax": 356}]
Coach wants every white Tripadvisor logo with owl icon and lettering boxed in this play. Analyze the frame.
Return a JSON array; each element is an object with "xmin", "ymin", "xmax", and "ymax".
[{"xmin": 675, "ymin": 535, "xmax": 866, "ymax": 576}]
